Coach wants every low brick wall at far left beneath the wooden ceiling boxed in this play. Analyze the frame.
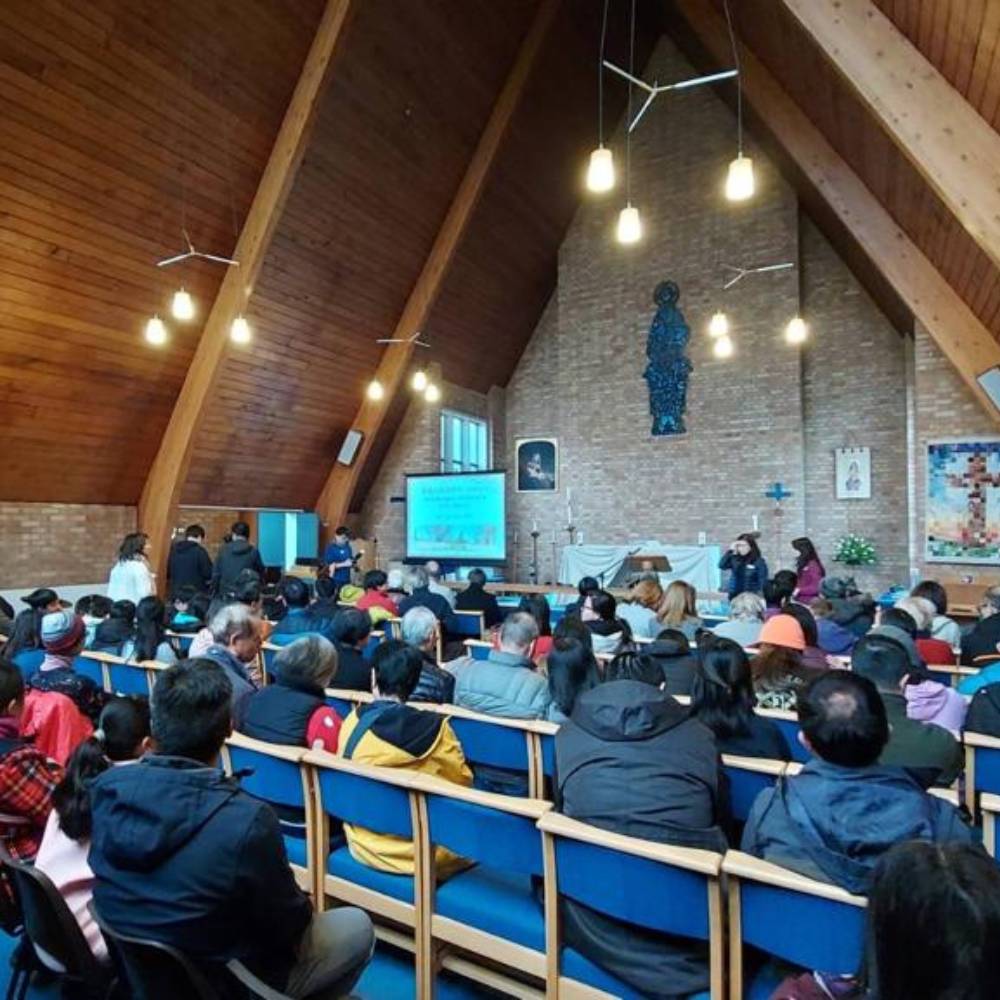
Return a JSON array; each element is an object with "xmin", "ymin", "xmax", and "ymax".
[{"xmin": 0, "ymin": 503, "xmax": 136, "ymax": 590}]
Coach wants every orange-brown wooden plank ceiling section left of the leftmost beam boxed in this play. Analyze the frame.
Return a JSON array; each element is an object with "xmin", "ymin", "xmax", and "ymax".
[{"xmin": 0, "ymin": 0, "xmax": 322, "ymax": 503}]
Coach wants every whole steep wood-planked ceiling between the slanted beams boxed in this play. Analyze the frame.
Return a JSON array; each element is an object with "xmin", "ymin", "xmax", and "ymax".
[{"xmin": 0, "ymin": 0, "xmax": 1000, "ymax": 507}]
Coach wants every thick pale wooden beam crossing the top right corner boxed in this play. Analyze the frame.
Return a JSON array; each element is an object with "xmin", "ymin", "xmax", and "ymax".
[{"xmin": 782, "ymin": 0, "xmax": 1000, "ymax": 278}]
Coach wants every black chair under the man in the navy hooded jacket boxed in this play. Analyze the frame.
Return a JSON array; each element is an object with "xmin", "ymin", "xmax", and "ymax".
[{"xmin": 90, "ymin": 902, "xmax": 291, "ymax": 1000}]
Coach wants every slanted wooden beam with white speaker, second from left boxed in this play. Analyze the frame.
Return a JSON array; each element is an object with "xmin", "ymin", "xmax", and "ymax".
[{"xmin": 316, "ymin": 0, "xmax": 559, "ymax": 530}]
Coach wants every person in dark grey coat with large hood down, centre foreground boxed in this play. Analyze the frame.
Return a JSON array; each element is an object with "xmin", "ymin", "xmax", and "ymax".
[{"xmin": 556, "ymin": 654, "xmax": 726, "ymax": 997}]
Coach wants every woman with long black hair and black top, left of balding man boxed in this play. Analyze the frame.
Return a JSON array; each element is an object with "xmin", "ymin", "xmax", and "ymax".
[{"xmin": 691, "ymin": 638, "xmax": 791, "ymax": 760}]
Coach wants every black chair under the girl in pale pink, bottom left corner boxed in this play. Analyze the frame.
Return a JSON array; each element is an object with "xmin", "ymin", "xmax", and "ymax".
[{"xmin": 0, "ymin": 846, "xmax": 115, "ymax": 1000}]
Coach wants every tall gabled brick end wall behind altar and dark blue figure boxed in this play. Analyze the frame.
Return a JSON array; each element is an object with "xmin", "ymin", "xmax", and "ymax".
[{"xmin": 354, "ymin": 39, "xmax": 920, "ymax": 589}]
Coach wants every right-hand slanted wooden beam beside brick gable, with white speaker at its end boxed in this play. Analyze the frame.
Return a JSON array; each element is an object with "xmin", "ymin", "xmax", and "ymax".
[{"xmin": 675, "ymin": 0, "xmax": 1000, "ymax": 422}]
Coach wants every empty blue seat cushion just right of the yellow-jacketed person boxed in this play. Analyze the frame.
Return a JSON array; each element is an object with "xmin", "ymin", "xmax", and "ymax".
[{"xmin": 434, "ymin": 865, "xmax": 545, "ymax": 952}]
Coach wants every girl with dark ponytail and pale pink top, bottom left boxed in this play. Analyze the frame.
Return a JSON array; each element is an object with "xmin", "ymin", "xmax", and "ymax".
[{"xmin": 35, "ymin": 698, "xmax": 149, "ymax": 961}]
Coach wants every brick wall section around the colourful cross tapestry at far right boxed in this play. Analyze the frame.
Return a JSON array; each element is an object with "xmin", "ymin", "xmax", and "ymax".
[{"xmin": 913, "ymin": 323, "xmax": 1000, "ymax": 584}]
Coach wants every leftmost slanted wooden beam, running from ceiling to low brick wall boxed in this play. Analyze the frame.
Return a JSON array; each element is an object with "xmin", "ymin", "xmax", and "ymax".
[{"xmin": 139, "ymin": 0, "xmax": 350, "ymax": 588}]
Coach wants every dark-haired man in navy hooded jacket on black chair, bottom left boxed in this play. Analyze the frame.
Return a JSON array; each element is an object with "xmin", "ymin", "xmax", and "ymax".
[{"xmin": 89, "ymin": 659, "xmax": 374, "ymax": 1000}]
